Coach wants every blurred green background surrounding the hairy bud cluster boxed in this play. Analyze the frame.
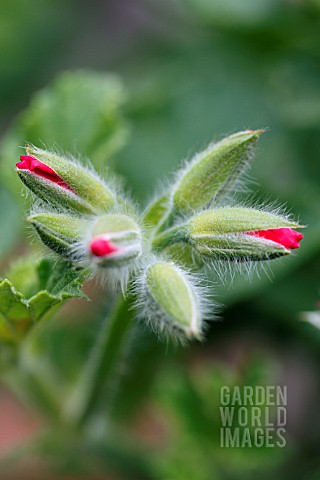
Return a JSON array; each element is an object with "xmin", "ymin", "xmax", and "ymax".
[{"xmin": 0, "ymin": 0, "xmax": 320, "ymax": 480}]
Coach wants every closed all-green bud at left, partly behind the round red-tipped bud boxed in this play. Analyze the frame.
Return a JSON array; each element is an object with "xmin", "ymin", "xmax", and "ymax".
[{"xmin": 27, "ymin": 213, "xmax": 88, "ymax": 260}]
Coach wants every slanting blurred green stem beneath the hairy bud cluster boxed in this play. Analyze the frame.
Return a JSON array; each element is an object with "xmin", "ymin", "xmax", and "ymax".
[{"xmin": 64, "ymin": 297, "xmax": 133, "ymax": 426}]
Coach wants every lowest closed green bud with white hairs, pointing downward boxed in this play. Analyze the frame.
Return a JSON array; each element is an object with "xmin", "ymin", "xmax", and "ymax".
[{"xmin": 138, "ymin": 261, "xmax": 203, "ymax": 340}]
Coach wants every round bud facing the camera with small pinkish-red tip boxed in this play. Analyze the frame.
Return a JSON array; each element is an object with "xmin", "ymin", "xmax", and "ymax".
[{"xmin": 88, "ymin": 214, "xmax": 142, "ymax": 268}]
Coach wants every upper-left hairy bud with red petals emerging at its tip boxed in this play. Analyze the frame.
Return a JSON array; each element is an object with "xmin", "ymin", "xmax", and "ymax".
[{"xmin": 16, "ymin": 146, "xmax": 114, "ymax": 213}]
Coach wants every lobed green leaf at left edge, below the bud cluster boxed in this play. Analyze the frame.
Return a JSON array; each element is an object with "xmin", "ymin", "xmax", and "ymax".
[{"xmin": 0, "ymin": 257, "xmax": 87, "ymax": 341}]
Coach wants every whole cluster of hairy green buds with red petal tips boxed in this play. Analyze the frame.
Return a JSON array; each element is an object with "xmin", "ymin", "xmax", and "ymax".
[{"xmin": 17, "ymin": 130, "xmax": 303, "ymax": 341}]
